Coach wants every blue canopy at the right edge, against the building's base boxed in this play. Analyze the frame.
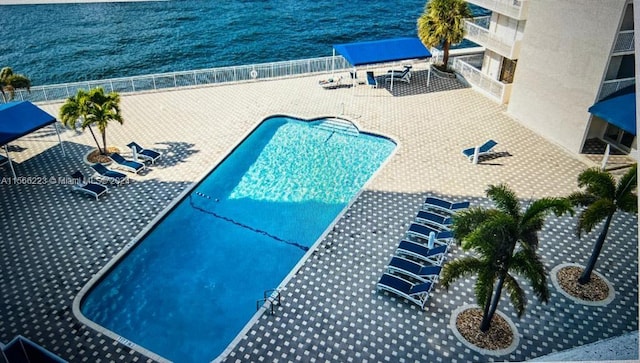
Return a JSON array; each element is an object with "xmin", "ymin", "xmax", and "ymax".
[{"xmin": 589, "ymin": 85, "xmax": 636, "ymax": 135}]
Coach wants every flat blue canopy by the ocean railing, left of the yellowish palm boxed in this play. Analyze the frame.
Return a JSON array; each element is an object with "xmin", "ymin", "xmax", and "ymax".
[{"xmin": 333, "ymin": 38, "xmax": 431, "ymax": 67}]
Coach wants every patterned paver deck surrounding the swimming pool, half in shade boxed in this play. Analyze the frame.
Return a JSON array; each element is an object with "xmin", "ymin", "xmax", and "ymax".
[{"xmin": 0, "ymin": 67, "xmax": 638, "ymax": 362}]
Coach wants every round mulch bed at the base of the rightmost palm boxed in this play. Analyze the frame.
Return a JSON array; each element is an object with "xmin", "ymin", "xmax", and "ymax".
[{"xmin": 557, "ymin": 266, "xmax": 609, "ymax": 301}]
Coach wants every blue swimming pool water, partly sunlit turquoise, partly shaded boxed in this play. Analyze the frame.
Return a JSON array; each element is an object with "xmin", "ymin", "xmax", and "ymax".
[{"xmin": 81, "ymin": 117, "xmax": 395, "ymax": 362}]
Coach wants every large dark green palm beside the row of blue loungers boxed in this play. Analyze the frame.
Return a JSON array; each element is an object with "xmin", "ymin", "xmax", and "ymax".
[{"xmin": 441, "ymin": 184, "xmax": 573, "ymax": 332}]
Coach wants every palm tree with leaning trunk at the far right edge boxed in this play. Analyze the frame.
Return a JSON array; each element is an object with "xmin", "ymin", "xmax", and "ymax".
[{"xmin": 568, "ymin": 164, "xmax": 638, "ymax": 284}]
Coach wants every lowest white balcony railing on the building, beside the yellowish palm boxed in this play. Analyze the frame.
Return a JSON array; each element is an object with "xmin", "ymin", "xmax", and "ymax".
[{"xmin": 453, "ymin": 55, "xmax": 511, "ymax": 103}]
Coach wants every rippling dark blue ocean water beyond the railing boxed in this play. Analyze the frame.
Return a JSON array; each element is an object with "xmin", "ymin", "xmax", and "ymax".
[{"xmin": 0, "ymin": 0, "xmax": 483, "ymax": 85}]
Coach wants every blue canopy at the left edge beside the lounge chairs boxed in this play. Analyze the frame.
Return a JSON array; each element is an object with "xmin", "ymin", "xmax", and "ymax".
[{"xmin": 0, "ymin": 101, "xmax": 56, "ymax": 145}]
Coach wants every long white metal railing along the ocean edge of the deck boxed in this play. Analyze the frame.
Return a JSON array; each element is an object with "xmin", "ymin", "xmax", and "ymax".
[{"xmin": 5, "ymin": 56, "xmax": 351, "ymax": 102}]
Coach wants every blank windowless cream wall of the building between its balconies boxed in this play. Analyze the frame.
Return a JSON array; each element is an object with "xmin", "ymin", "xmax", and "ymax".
[{"xmin": 507, "ymin": 0, "xmax": 625, "ymax": 153}]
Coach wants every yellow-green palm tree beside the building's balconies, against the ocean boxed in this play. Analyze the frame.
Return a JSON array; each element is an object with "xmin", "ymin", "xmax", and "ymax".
[{"xmin": 418, "ymin": 0, "xmax": 471, "ymax": 68}]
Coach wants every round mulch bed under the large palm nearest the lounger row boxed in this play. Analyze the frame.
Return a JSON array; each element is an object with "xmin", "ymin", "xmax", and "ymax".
[{"xmin": 456, "ymin": 308, "xmax": 514, "ymax": 350}]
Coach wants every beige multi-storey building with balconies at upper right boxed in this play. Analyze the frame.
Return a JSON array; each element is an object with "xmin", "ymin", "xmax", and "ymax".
[{"xmin": 454, "ymin": 0, "xmax": 637, "ymax": 158}]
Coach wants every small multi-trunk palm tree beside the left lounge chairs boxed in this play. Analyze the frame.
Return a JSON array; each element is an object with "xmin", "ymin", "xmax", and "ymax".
[{"xmin": 60, "ymin": 87, "xmax": 124, "ymax": 154}]
